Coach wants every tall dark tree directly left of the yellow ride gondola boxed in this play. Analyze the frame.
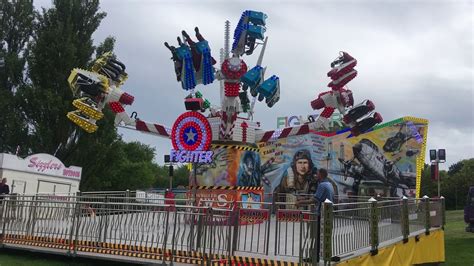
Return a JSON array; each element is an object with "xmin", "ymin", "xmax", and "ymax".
[{"xmin": 18, "ymin": 0, "xmax": 107, "ymax": 158}]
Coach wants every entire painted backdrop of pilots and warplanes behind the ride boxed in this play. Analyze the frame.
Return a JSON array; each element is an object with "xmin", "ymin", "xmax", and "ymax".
[{"xmin": 191, "ymin": 118, "xmax": 427, "ymax": 201}]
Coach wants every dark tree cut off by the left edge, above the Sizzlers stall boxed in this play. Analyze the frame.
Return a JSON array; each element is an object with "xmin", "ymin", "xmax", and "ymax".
[{"xmin": 0, "ymin": 0, "xmax": 36, "ymax": 153}]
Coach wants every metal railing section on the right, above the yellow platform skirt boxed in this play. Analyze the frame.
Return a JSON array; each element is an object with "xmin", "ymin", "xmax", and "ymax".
[{"xmin": 321, "ymin": 196, "xmax": 446, "ymax": 262}]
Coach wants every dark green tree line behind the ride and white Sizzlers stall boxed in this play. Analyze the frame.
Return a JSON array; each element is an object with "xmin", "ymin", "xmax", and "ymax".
[{"xmin": 0, "ymin": 0, "xmax": 188, "ymax": 191}]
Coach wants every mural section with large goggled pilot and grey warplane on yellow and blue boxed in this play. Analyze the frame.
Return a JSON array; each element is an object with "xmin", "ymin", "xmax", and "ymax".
[{"xmin": 260, "ymin": 119, "xmax": 427, "ymax": 198}]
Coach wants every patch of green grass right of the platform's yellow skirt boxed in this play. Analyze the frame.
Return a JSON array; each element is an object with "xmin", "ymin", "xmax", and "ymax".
[{"xmin": 444, "ymin": 210, "xmax": 474, "ymax": 266}]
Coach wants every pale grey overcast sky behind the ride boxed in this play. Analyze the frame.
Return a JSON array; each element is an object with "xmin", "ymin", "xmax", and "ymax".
[{"xmin": 37, "ymin": 0, "xmax": 474, "ymax": 166}]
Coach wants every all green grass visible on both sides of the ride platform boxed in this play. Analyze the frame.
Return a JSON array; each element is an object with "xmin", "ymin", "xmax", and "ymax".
[{"xmin": 0, "ymin": 211, "xmax": 474, "ymax": 266}]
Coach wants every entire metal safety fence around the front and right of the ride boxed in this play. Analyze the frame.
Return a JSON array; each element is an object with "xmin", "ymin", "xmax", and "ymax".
[{"xmin": 0, "ymin": 192, "xmax": 445, "ymax": 265}]
